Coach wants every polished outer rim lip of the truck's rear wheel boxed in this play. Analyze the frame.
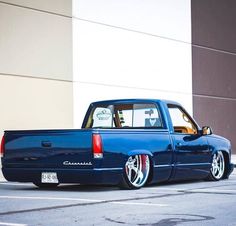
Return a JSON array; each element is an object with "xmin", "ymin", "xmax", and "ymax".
[{"xmin": 125, "ymin": 154, "xmax": 151, "ymax": 188}]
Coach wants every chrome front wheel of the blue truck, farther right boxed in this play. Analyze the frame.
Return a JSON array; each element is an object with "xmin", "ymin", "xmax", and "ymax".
[{"xmin": 211, "ymin": 151, "xmax": 225, "ymax": 180}]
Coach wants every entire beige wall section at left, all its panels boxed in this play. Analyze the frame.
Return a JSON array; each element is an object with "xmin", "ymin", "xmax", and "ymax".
[{"xmin": 0, "ymin": 0, "xmax": 73, "ymax": 134}]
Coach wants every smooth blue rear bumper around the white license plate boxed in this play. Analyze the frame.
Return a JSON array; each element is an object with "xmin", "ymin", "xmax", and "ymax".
[{"xmin": 2, "ymin": 168, "xmax": 123, "ymax": 185}]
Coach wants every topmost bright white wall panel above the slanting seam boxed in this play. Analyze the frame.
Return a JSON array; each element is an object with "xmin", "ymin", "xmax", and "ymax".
[{"xmin": 73, "ymin": 0, "xmax": 191, "ymax": 43}]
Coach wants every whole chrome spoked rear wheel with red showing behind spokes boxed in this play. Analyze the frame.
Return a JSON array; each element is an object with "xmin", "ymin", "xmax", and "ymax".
[{"xmin": 125, "ymin": 155, "xmax": 150, "ymax": 188}]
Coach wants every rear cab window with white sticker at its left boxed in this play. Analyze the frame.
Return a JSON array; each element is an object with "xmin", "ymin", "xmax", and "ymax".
[{"xmin": 86, "ymin": 103, "xmax": 163, "ymax": 128}]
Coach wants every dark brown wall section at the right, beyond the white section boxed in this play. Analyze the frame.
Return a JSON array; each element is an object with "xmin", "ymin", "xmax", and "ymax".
[{"xmin": 192, "ymin": 0, "xmax": 236, "ymax": 154}]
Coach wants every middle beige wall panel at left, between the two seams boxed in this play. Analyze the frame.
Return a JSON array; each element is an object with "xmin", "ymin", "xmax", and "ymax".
[{"xmin": 0, "ymin": 3, "xmax": 72, "ymax": 81}]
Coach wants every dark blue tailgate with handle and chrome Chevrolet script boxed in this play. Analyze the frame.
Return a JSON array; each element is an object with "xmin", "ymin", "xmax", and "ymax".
[{"xmin": 2, "ymin": 130, "xmax": 93, "ymax": 169}]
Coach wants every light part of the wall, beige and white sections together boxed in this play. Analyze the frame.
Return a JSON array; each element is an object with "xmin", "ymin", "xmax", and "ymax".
[{"xmin": 0, "ymin": 0, "xmax": 192, "ymax": 133}]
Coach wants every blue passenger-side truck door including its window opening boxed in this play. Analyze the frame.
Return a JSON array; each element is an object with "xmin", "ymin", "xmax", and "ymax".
[{"xmin": 168, "ymin": 104, "xmax": 211, "ymax": 180}]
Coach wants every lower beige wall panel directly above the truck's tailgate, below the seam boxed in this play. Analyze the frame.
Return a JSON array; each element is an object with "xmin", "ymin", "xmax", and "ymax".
[{"xmin": 0, "ymin": 75, "xmax": 73, "ymax": 132}]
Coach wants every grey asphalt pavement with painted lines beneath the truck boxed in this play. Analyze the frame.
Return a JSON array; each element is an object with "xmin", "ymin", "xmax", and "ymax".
[{"xmin": 0, "ymin": 167, "xmax": 236, "ymax": 226}]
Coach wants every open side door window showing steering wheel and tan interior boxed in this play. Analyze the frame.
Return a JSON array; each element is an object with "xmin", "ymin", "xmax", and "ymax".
[{"xmin": 168, "ymin": 105, "xmax": 197, "ymax": 134}]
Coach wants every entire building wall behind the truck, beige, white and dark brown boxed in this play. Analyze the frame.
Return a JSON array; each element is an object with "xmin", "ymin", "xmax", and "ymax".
[{"xmin": 0, "ymin": 0, "xmax": 232, "ymax": 162}]
